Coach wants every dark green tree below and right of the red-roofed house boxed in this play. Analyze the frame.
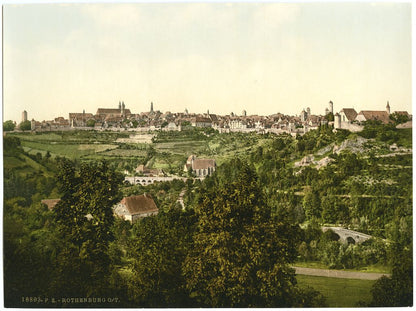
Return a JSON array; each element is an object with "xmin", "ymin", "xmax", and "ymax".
[{"xmin": 128, "ymin": 208, "xmax": 196, "ymax": 307}]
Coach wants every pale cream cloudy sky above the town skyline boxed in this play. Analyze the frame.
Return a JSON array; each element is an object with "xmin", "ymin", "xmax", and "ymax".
[{"xmin": 3, "ymin": 2, "xmax": 412, "ymax": 123}]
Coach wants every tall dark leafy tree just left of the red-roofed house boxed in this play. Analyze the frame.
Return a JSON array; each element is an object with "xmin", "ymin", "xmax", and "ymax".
[{"xmin": 53, "ymin": 159, "xmax": 123, "ymax": 297}]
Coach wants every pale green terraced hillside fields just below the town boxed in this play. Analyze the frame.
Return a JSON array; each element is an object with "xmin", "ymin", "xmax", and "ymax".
[{"xmin": 8, "ymin": 130, "xmax": 268, "ymax": 174}]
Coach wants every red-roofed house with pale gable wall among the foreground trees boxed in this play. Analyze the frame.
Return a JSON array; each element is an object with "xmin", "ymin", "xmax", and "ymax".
[{"xmin": 113, "ymin": 193, "xmax": 159, "ymax": 222}]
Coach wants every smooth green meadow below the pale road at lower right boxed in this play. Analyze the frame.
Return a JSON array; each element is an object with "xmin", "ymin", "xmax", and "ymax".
[{"xmin": 296, "ymin": 275, "xmax": 375, "ymax": 308}]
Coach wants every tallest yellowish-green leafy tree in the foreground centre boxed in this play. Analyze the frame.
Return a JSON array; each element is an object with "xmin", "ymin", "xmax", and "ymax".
[{"xmin": 184, "ymin": 160, "xmax": 304, "ymax": 307}]
